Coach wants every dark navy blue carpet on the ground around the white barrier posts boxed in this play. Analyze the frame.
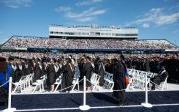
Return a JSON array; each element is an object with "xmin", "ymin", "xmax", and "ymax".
[{"xmin": 0, "ymin": 91, "xmax": 179, "ymax": 112}]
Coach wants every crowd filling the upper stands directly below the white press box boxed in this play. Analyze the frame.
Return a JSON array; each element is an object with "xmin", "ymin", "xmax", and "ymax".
[{"xmin": 3, "ymin": 37, "xmax": 177, "ymax": 50}]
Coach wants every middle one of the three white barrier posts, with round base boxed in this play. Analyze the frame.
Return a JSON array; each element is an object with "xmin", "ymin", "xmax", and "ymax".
[{"xmin": 79, "ymin": 76, "xmax": 90, "ymax": 111}]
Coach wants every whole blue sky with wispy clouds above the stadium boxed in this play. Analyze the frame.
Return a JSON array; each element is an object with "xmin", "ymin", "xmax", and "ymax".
[{"xmin": 0, "ymin": 0, "xmax": 179, "ymax": 45}]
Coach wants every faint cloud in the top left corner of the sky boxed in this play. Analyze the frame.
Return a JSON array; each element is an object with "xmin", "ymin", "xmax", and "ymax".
[{"xmin": 3, "ymin": 0, "xmax": 32, "ymax": 8}]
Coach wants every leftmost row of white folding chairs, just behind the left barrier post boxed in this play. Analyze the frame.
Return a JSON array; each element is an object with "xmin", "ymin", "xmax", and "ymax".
[{"xmin": 12, "ymin": 73, "xmax": 34, "ymax": 93}]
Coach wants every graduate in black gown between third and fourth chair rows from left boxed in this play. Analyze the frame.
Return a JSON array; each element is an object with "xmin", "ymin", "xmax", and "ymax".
[{"xmin": 62, "ymin": 58, "xmax": 74, "ymax": 91}]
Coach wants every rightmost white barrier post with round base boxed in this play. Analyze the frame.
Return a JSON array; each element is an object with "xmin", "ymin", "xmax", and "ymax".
[{"xmin": 141, "ymin": 74, "xmax": 152, "ymax": 108}]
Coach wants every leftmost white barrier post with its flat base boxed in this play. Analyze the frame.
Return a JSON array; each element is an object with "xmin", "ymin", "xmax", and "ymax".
[{"xmin": 3, "ymin": 77, "xmax": 16, "ymax": 112}]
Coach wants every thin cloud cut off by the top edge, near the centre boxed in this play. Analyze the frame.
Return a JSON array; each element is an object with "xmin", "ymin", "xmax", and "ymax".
[{"xmin": 76, "ymin": 0, "xmax": 103, "ymax": 6}]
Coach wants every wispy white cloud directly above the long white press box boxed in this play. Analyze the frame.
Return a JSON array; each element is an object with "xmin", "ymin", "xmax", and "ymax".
[{"xmin": 55, "ymin": 6, "xmax": 106, "ymax": 22}]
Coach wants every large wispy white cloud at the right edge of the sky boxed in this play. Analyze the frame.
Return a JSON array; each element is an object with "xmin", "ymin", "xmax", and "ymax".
[{"xmin": 132, "ymin": 8, "xmax": 179, "ymax": 28}]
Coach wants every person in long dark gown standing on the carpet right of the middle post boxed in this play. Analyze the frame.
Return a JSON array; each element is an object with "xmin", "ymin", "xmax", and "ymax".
[{"xmin": 112, "ymin": 58, "xmax": 126, "ymax": 104}]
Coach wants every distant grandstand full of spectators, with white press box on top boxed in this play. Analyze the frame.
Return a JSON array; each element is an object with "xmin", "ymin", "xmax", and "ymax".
[{"xmin": 1, "ymin": 25, "xmax": 178, "ymax": 51}]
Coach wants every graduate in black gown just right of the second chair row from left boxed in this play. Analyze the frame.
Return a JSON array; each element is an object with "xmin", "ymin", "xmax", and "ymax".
[{"xmin": 46, "ymin": 59, "xmax": 56, "ymax": 92}]
